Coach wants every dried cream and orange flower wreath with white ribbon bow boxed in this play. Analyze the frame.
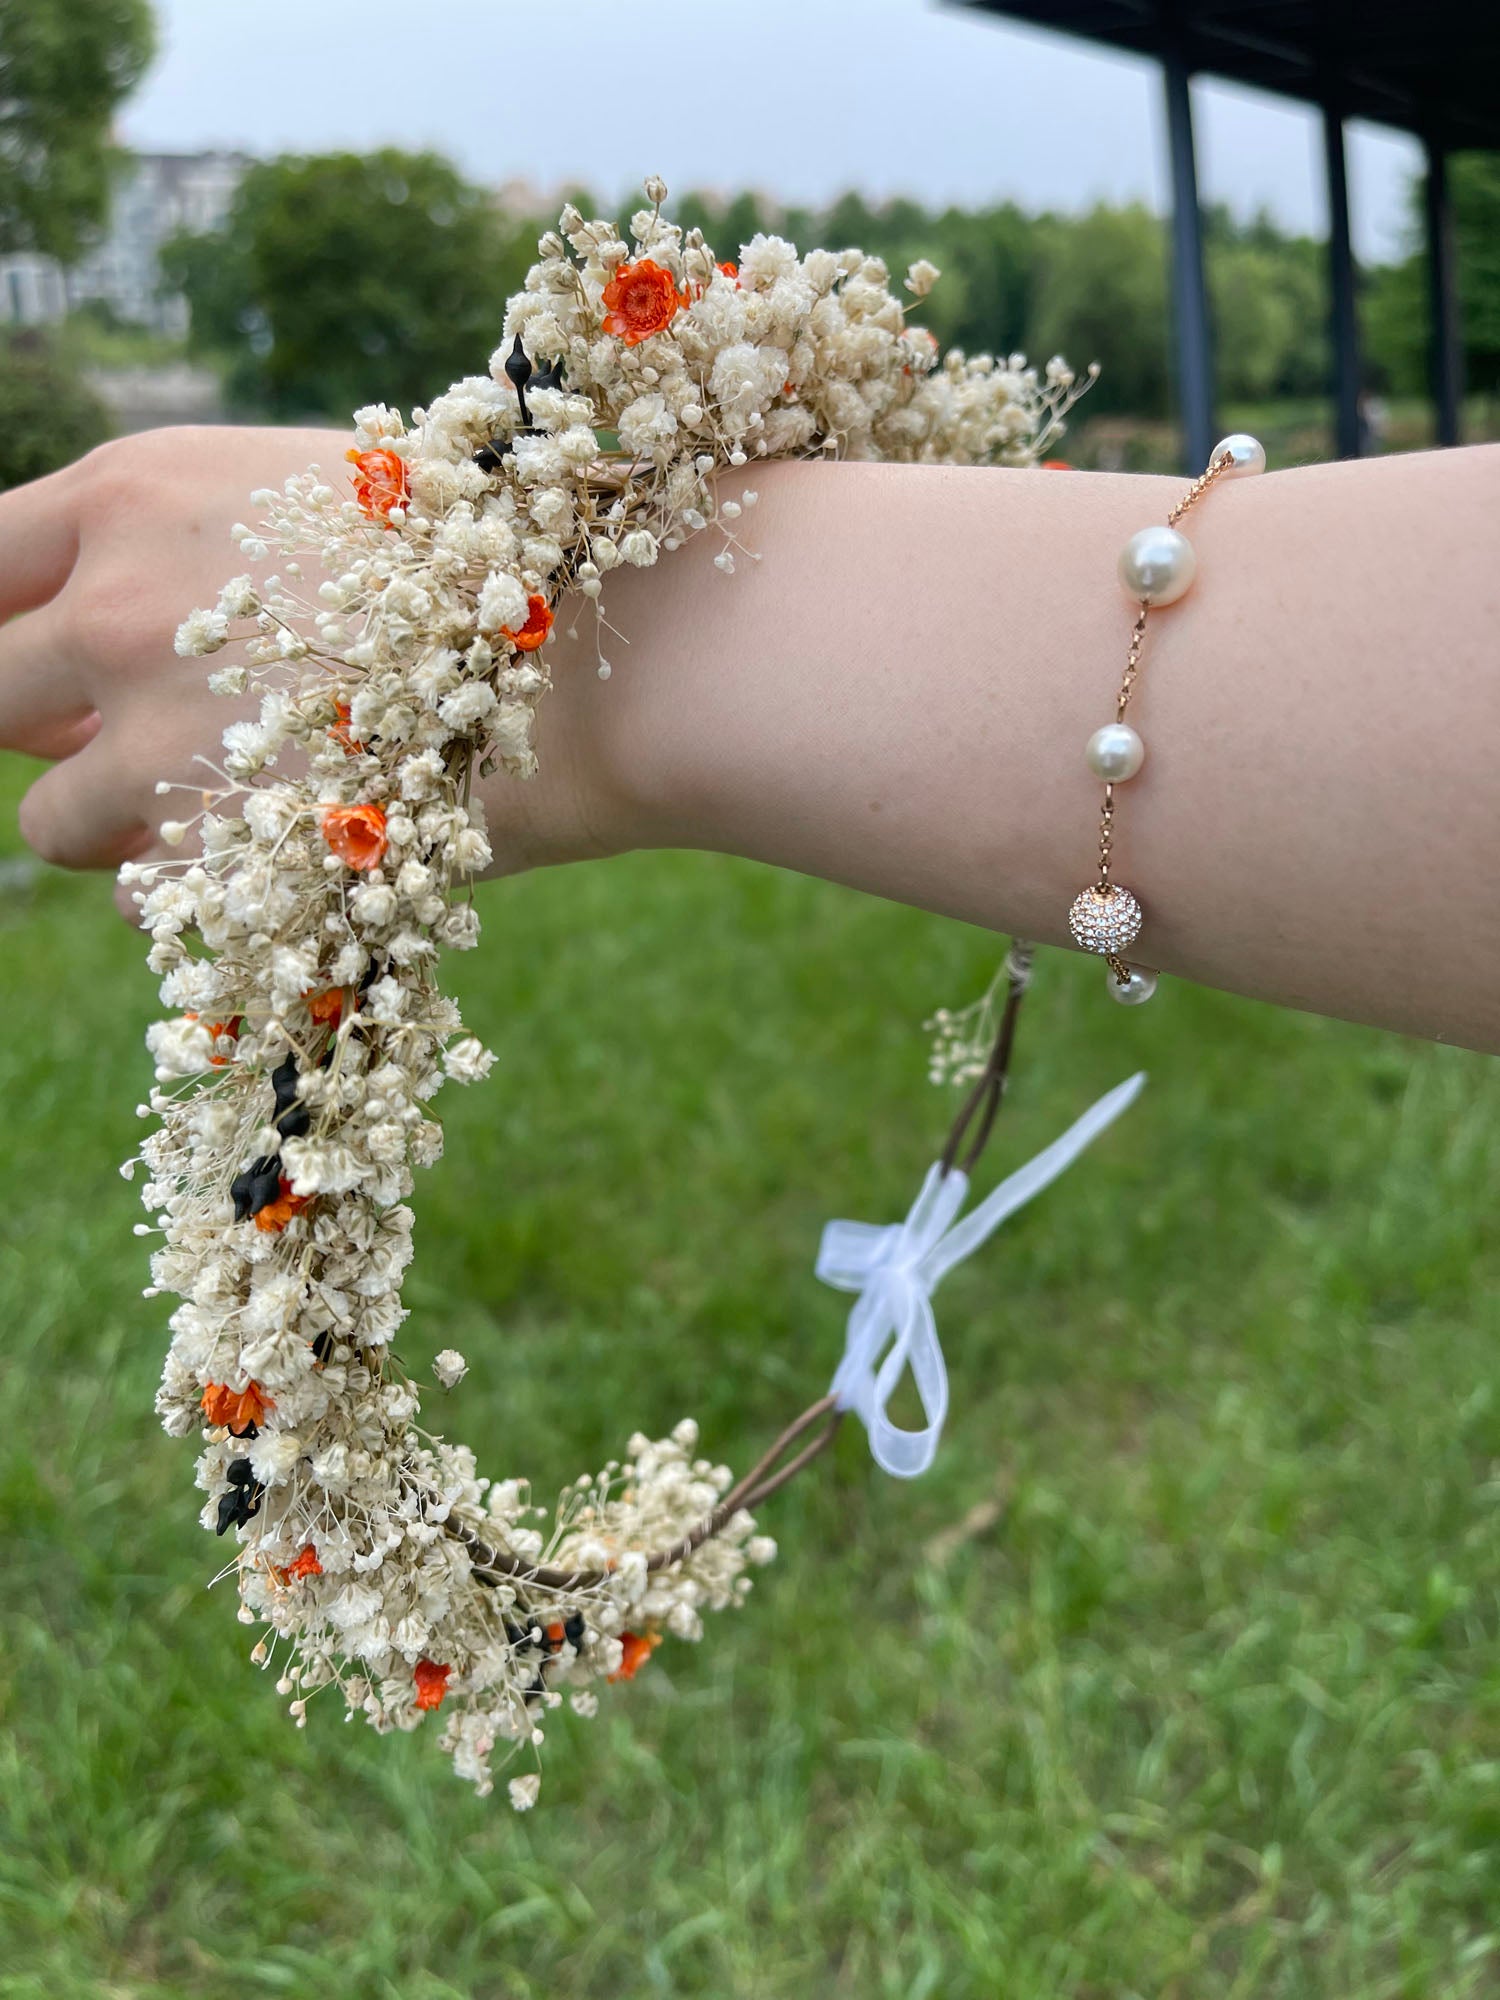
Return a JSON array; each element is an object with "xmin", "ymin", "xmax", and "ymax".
[{"xmin": 122, "ymin": 180, "xmax": 1138, "ymax": 1810}]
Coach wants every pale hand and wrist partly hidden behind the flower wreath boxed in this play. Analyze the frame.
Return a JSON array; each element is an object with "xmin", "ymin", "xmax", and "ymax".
[{"xmin": 0, "ymin": 426, "xmax": 618, "ymax": 920}]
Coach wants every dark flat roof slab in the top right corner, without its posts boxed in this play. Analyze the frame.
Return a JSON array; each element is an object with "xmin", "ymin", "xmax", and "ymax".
[{"xmin": 950, "ymin": 0, "xmax": 1500, "ymax": 148}]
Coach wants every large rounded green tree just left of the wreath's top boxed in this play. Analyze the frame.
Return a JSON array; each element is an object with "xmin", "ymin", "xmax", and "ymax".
[{"xmin": 162, "ymin": 148, "xmax": 536, "ymax": 418}]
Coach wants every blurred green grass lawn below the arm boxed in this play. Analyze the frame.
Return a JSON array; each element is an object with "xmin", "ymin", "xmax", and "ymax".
[{"xmin": 0, "ymin": 760, "xmax": 1500, "ymax": 2000}]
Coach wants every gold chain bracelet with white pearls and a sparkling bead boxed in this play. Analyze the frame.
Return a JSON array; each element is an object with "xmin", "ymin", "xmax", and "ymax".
[{"xmin": 1068, "ymin": 432, "xmax": 1266, "ymax": 1006}]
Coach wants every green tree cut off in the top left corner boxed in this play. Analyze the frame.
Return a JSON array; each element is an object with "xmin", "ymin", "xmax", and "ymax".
[{"xmin": 0, "ymin": 0, "xmax": 156, "ymax": 264}]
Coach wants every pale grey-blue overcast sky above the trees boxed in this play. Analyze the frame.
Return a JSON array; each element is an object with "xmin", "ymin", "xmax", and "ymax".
[{"xmin": 120, "ymin": 0, "xmax": 1418, "ymax": 256}]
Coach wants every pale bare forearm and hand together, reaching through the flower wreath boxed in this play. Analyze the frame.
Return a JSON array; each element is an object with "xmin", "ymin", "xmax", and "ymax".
[{"xmin": 0, "ymin": 428, "xmax": 1500, "ymax": 1052}]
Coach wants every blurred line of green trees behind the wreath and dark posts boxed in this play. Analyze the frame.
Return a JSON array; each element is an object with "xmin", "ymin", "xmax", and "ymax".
[{"xmin": 164, "ymin": 148, "xmax": 1500, "ymax": 430}]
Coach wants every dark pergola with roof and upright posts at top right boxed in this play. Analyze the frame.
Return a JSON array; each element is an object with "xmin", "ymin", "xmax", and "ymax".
[{"xmin": 956, "ymin": 0, "xmax": 1500, "ymax": 464}]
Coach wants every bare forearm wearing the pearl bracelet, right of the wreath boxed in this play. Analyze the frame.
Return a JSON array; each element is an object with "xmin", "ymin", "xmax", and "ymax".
[{"xmin": 540, "ymin": 446, "xmax": 1500, "ymax": 1050}]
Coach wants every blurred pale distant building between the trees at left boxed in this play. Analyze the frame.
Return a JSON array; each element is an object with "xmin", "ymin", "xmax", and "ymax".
[{"xmin": 0, "ymin": 152, "xmax": 250, "ymax": 338}]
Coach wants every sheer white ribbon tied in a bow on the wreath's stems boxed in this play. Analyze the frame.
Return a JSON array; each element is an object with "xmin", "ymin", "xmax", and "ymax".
[{"xmin": 816, "ymin": 1072, "xmax": 1146, "ymax": 1480}]
